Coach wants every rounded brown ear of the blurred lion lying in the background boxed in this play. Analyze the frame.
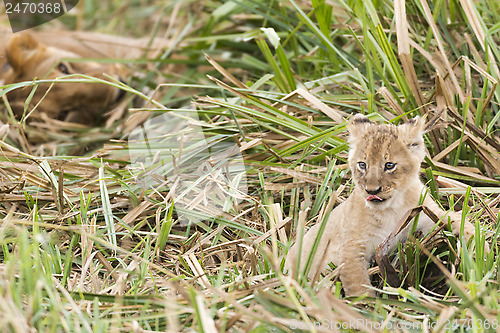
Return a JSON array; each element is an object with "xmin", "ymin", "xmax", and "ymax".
[{"xmin": 6, "ymin": 32, "xmax": 40, "ymax": 71}]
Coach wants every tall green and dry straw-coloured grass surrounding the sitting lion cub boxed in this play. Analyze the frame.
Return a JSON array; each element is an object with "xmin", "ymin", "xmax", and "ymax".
[{"xmin": 0, "ymin": 0, "xmax": 500, "ymax": 332}]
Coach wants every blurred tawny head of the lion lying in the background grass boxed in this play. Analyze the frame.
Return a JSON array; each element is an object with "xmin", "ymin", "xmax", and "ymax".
[{"xmin": 4, "ymin": 32, "xmax": 123, "ymax": 124}]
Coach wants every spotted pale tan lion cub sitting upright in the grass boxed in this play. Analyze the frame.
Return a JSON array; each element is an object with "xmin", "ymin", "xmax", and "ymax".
[{"xmin": 285, "ymin": 114, "xmax": 474, "ymax": 296}]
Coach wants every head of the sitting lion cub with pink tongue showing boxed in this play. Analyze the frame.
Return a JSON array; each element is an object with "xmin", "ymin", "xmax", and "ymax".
[{"xmin": 348, "ymin": 114, "xmax": 425, "ymax": 208}]
